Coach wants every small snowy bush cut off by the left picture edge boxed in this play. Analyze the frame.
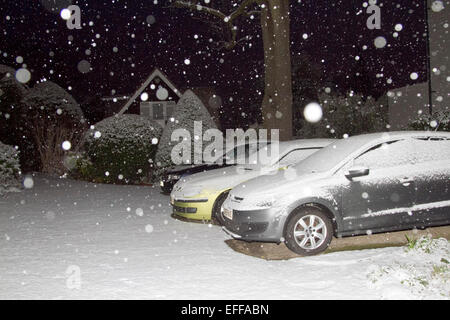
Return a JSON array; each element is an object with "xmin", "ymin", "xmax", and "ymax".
[{"xmin": 0, "ymin": 142, "xmax": 20, "ymax": 195}]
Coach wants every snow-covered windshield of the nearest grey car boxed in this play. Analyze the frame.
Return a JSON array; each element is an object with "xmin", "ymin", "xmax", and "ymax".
[{"xmin": 294, "ymin": 137, "xmax": 368, "ymax": 174}]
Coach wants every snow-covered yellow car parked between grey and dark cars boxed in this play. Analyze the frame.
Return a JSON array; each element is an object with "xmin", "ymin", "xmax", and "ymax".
[{"xmin": 170, "ymin": 139, "xmax": 334, "ymax": 224}]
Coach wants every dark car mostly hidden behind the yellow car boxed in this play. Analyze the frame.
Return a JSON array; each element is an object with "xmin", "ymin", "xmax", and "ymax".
[{"xmin": 159, "ymin": 140, "xmax": 269, "ymax": 194}]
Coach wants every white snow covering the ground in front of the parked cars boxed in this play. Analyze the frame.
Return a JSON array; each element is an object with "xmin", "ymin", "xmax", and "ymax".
[{"xmin": 0, "ymin": 176, "xmax": 450, "ymax": 299}]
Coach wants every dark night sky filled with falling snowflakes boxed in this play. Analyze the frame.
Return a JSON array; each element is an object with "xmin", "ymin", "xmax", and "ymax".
[{"xmin": 0, "ymin": 0, "xmax": 426, "ymax": 127}]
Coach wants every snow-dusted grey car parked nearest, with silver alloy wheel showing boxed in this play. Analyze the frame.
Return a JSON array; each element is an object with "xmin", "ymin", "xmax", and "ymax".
[{"xmin": 221, "ymin": 131, "xmax": 450, "ymax": 255}]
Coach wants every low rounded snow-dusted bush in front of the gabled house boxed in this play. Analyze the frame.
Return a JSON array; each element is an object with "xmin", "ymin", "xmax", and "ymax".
[{"xmin": 72, "ymin": 114, "xmax": 162, "ymax": 184}]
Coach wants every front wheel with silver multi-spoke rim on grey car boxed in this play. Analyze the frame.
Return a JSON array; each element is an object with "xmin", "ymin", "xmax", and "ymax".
[{"xmin": 285, "ymin": 207, "xmax": 333, "ymax": 256}]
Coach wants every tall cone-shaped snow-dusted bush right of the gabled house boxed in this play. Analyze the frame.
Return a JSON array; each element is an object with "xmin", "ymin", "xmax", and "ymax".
[{"xmin": 155, "ymin": 90, "xmax": 217, "ymax": 176}]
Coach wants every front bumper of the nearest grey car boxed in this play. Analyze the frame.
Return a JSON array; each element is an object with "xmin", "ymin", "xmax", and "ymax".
[{"xmin": 222, "ymin": 208, "xmax": 286, "ymax": 242}]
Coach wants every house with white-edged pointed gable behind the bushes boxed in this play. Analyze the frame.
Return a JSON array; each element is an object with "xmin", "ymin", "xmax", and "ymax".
[{"xmin": 102, "ymin": 68, "xmax": 221, "ymax": 128}]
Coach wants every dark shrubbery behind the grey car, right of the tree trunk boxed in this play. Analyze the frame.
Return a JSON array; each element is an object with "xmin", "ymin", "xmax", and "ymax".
[{"xmin": 297, "ymin": 92, "xmax": 388, "ymax": 138}]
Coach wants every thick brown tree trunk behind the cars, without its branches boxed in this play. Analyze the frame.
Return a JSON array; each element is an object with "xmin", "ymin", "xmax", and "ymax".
[{"xmin": 261, "ymin": 0, "xmax": 292, "ymax": 141}]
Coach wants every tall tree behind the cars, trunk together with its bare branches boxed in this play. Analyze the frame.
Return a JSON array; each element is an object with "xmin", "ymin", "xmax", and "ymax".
[{"xmin": 172, "ymin": 0, "xmax": 292, "ymax": 140}]
